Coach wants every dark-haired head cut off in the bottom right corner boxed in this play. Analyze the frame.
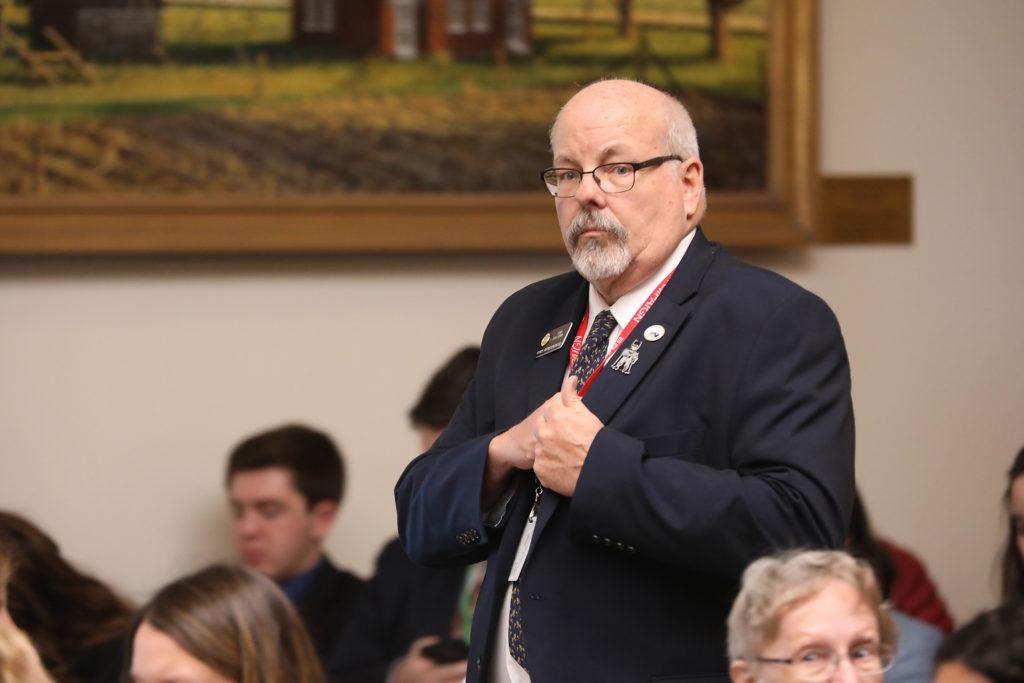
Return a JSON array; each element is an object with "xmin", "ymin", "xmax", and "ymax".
[{"xmin": 935, "ymin": 602, "xmax": 1024, "ymax": 683}]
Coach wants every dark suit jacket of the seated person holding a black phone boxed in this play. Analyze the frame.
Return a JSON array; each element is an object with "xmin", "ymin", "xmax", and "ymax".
[{"xmin": 328, "ymin": 539, "xmax": 466, "ymax": 683}]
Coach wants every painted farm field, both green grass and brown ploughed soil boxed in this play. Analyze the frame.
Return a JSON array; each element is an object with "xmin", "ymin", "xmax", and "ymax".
[{"xmin": 0, "ymin": 0, "xmax": 767, "ymax": 196}]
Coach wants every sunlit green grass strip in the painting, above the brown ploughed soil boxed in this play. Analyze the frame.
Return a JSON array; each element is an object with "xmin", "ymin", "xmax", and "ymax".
[{"xmin": 0, "ymin": 0, "xmax": 765, "ymax": 120}]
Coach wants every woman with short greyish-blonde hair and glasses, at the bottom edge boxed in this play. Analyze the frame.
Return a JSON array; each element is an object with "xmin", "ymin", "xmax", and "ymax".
[{"xmin": 728, "ymin": 550, "xmax": 896, "ymax": 683}]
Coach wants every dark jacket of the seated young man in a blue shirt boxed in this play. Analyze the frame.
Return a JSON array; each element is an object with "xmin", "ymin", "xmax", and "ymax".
[{"xmin": 295, "ymin": 555, "xmax": 364, "ymax": 664}]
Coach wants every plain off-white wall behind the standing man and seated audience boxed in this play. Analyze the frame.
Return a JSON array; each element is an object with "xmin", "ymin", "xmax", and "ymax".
[{"xmin": 0, "ymin": 0, "xmax": 1024, "ymax": 618}]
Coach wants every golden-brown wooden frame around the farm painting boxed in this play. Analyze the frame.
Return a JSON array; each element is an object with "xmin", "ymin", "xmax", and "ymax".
[{"xmin": 0, "ymin": 0, "xmax": 820, "ymax": 255}]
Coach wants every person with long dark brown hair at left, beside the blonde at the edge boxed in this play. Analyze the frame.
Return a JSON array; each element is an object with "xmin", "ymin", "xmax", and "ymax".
[{"xmin": 0, "ymin": 511, "xmax": 131, "ymax": 683}]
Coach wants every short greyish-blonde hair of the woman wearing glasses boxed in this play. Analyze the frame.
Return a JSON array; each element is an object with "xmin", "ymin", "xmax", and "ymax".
[{"xmin": 728, "ymin": 550, "xmax": 897, "ymax": 660}]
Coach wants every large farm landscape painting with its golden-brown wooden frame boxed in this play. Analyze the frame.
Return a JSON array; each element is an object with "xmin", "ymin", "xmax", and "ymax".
[{"xmin": 0, "ymin": 0, "xmax": 819, "ymax": 255}]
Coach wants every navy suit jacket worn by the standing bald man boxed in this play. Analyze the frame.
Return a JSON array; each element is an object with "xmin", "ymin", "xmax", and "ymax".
[{"xmin": 395, "ymin": 230, "xmax": 853, "ymax": 683}]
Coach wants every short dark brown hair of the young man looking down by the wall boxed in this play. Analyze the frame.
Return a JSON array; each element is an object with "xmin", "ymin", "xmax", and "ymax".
[{"xmin": 225, "ymin": 425, "xmax": 345, "ymax": 508}]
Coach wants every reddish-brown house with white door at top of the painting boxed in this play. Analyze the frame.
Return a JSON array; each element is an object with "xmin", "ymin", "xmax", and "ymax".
[{"xmin": 292, "ymin": 0, "xmax": 532, "ymax": 59}]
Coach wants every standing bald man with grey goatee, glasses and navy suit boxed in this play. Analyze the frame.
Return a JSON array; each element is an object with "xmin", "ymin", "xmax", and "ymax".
[{"xmin": 395, "ymin": 81, "xmax": 853, "ymax": 683}]
